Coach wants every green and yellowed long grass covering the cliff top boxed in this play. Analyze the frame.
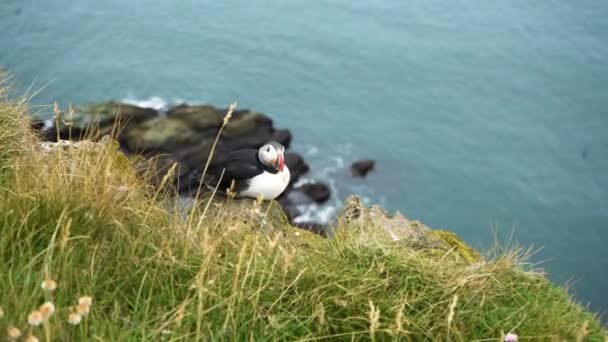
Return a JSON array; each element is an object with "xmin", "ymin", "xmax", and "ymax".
[{"xmin": 0, "ymin": 81, "xmax": 605, "ymax": 341}]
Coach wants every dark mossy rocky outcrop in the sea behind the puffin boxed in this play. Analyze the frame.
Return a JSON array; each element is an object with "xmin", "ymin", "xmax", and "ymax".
[{"xmin": 32, "ymin": 102, "xmax": 324, "ymax": 217}]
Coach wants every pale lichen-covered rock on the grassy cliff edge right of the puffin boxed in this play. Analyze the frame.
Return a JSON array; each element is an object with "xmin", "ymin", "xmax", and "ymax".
[{"xmin": 338, "ymin": 196, "xmax": 482, "ymax": 263}]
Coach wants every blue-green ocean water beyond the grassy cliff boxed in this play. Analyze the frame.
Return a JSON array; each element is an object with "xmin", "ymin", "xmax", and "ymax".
[{"xmin": 0, "ymin": 0, "xmax": 608, "ymax": 313}]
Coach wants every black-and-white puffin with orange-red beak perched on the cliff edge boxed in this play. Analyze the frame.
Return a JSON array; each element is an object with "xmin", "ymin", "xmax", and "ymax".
[{"xmin": 204, "ymin": 141, "xmax": 291, "ymax": 200}]
